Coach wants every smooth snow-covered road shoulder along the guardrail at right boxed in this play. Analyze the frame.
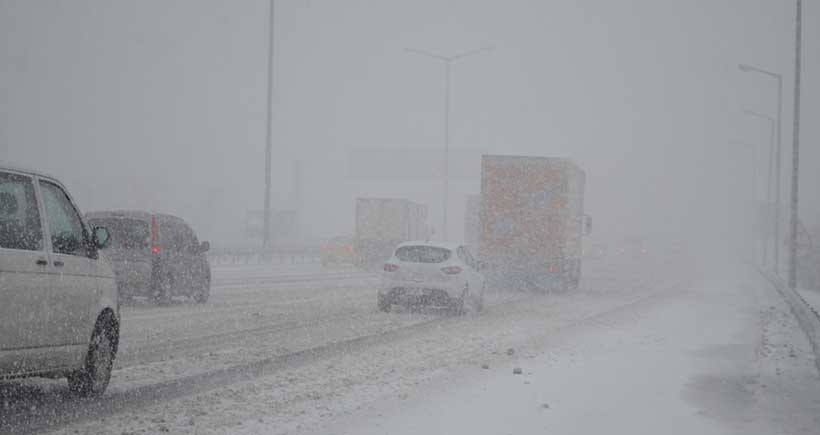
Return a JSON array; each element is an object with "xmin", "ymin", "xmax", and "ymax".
[{"xmin": 316, "ymin": 268, "xmax": 820, "ymax": 435}]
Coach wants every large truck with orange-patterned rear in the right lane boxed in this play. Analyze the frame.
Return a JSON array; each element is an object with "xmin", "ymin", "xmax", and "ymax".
[{"xmin": 479, "ymin": 155, "xmax": 591, "ymax": 291}]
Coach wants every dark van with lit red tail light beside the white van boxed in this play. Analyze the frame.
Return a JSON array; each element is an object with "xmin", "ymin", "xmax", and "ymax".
[{"xmin": 86, "ymin": 210, "xmax": 211, "ymax": 304}]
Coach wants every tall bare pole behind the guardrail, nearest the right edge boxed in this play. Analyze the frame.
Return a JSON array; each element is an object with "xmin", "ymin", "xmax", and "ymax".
[{"xmin": 789, "ymin": 0, "xmax": 803, "ymax": 289}]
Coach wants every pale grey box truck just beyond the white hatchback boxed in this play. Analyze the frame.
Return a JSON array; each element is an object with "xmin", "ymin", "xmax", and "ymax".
[{"xmin": 353, "ymin": 198, "xmax": 428, "ymax": 271}]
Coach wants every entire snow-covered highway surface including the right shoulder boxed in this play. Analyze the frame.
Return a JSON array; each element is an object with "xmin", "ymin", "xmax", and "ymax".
[{"xmin": 0, "ymin": 259, "xmax": 820, "ymax": 434}]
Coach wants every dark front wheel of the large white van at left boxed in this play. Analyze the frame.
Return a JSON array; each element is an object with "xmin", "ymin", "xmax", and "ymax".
[{"xmin": 68, "ymin": 317, "xmax": 117, "ymax": 397}]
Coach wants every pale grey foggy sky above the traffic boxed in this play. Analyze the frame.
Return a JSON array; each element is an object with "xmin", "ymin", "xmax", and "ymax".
[{"xmin": 0, "ymin": 0, "xmax": 820, "ymax": 247}]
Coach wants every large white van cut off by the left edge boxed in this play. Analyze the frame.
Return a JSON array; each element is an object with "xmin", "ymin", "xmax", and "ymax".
[{"xmin": 0, "ymin": 167, "xmax": 120, "ymax": 396}]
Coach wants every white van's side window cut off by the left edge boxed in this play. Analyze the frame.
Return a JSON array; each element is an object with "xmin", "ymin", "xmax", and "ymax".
[{"xmin": 0, "ymin": 172, "xmax": 44, "ymax": 251}]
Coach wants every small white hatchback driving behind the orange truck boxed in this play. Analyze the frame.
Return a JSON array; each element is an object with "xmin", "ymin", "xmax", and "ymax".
[{"xmin": 378, "ymin": 242, "xmax": 484, "ymax": 314}]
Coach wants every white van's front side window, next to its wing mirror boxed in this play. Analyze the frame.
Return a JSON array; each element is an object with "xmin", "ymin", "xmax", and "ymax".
[{"xmin": 40, "ymin": 181, "xmax": 88, "ymax": 256}]
